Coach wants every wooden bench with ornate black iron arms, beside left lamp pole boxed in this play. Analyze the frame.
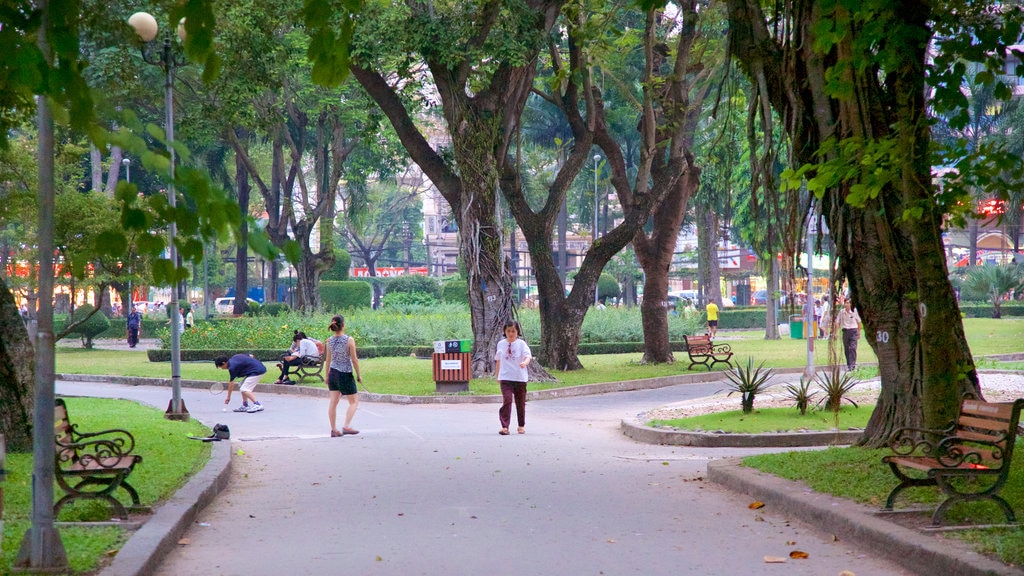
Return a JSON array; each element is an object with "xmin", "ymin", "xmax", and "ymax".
[{"xmin": 53, "ymin": 398, "xmax": 142, "ymax": 520}]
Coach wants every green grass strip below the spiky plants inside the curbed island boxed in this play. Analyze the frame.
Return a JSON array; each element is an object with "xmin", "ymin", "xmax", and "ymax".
[{"xmin": 648, "ymin": 406, "xmax": 874, "ymax": 434}]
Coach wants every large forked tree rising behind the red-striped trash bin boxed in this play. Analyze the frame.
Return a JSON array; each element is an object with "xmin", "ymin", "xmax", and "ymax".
[{"xmin": 351, "ymin": 0, "xmax": 564, "ymax": 376}]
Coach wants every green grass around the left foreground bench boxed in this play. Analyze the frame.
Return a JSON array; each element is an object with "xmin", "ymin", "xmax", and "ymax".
[{"xmin": 0, "ymin": 398, "xmax": 210, "ymax": 574}]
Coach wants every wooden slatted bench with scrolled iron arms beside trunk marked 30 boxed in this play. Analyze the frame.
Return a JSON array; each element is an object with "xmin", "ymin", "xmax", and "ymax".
[{"xmin": 882, "ymin": 399, "xmax": 1024, "ymax": 526}]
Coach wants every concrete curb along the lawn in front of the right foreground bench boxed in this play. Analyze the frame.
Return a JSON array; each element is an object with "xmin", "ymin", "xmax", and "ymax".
[{"xmin": 708, "ymin": 458, "xmax": 1021, "ymax": 576}]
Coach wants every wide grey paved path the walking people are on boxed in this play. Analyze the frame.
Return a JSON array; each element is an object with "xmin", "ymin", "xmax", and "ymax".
[{"xmin": 57, "ymin": 382, "xmax": 907, "ymax": 576}]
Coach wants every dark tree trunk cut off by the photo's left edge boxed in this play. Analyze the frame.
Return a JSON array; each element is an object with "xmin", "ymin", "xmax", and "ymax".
[{"xmin": 0, "ymin": 275, "xmax": 36, "ymax": 452}]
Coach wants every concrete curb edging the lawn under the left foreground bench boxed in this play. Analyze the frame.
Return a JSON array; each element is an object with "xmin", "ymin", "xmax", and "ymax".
[{"xmin": 99, "ymin": 442, "xmax": 232, "ymax": 576}]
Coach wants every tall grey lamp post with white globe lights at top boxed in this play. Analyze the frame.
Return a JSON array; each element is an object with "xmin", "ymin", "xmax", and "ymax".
[{"xmin": 128, "ymin": 12, "xmax": 188, "ymax": 420}]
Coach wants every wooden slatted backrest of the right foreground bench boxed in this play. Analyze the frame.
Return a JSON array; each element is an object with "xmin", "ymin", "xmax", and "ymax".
[{"xmin": 944, "ymin": 399, "xmax": 1024, "ymax": 468}]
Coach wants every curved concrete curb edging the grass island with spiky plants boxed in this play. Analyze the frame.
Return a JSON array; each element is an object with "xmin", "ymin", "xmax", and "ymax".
[{"xmin": 621, "ymin": 420, "xmax": 864, "ymax": 448}]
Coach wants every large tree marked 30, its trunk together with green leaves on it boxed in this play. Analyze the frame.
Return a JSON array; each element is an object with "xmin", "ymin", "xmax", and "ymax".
[{"xmin": 726, "ymin": 0, "xmax": 1020, "ymax": 446}]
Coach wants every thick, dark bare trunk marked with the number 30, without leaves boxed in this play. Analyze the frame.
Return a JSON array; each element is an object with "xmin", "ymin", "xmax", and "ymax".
[{"xmin": 727, "ymin": 0, "xmax": 980, "ymax": 446}]
